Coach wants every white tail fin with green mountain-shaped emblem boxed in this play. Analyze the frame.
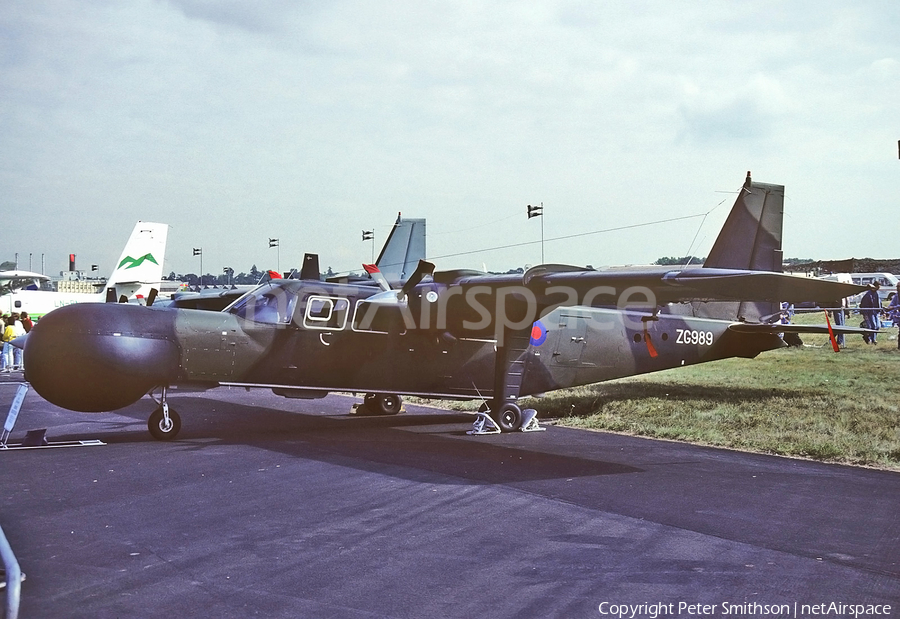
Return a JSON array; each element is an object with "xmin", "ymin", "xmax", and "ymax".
[{"xmin": 106, "ymin": 221, "xmax": 169, "ymax": 299}]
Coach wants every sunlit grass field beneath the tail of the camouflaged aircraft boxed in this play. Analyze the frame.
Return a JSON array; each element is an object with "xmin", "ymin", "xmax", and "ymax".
[{"xmin": 442, "ymin": 313, "xmax": 900, "ymax": 470}]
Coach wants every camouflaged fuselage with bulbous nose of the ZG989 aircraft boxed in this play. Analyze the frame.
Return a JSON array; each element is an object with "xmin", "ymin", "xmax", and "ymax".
[{"xmin": 19, "ymin": 281, "xmax": 783, "ymax": 412}]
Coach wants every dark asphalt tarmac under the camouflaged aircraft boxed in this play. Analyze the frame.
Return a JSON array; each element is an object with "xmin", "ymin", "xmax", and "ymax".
[{"xmin": 0, "ymin": 375, "xmax": 900, "ymax": 618}]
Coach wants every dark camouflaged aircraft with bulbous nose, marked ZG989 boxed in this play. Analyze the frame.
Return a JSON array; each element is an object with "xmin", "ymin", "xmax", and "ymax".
[{"xmin": 25, "ymin": 173, "xmax": 862, "ymax": 440}]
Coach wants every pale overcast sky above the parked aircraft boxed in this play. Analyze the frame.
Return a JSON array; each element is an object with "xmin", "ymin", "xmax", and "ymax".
[{"xmin": 0, "ymin": 0, "xmax": 900, "ymax": 275}]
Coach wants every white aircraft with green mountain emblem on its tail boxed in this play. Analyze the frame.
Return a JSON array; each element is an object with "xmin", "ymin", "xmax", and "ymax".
[{"xmin": 0, "ymin": 221, "xmax": 169, "ymax": 318}]
